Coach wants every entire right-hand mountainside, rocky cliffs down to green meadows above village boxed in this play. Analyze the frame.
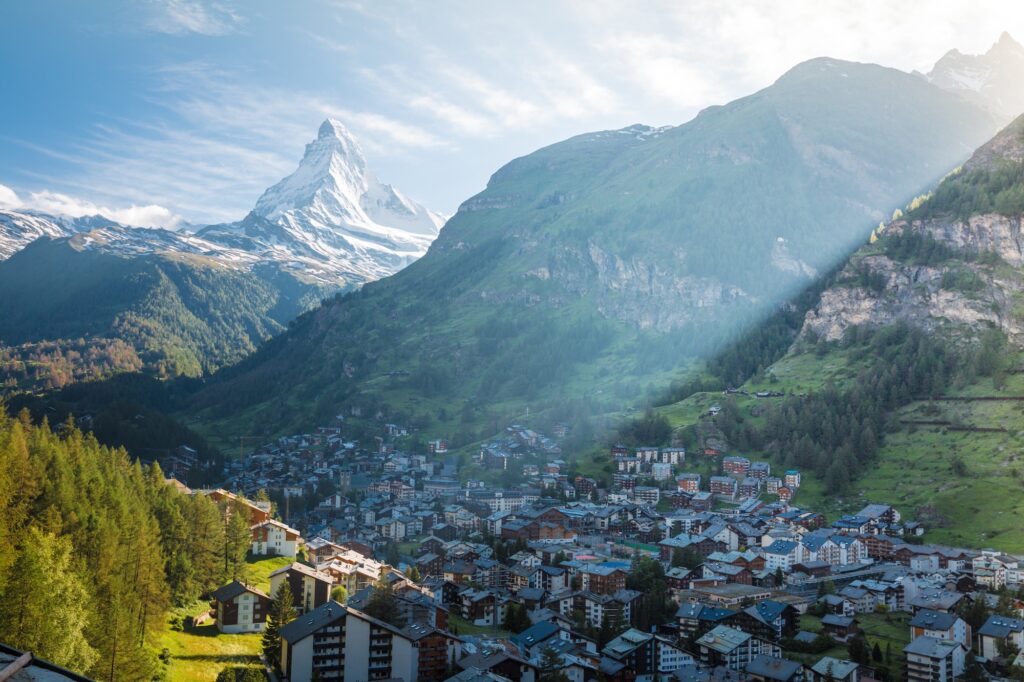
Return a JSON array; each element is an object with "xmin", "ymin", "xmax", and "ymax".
[{"xmin": 657, "ymin": 117, "xmax": 1024, "ymax": 552}]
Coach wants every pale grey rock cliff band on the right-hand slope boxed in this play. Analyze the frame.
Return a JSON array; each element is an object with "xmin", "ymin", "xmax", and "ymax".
[{"xmin": 801, "ymin": 214, "xmax": 1024, "ymax": 345}]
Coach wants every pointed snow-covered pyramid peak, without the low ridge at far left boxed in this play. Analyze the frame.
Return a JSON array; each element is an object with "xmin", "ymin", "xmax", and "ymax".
[{"xmin": 198, "ymin": 119, "xmax": 444, "ymax": 286}]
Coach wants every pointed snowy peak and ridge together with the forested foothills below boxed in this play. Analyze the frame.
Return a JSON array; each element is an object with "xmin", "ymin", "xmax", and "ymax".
[{"xmin": 0, "ymin": 120, "xmax": 442, "ymax": 389}]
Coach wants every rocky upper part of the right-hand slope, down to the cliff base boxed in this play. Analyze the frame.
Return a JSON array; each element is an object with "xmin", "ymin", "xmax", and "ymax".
[{"xmin": 803, "ymin": 116, "xmax": 1024, "ymax": 345}]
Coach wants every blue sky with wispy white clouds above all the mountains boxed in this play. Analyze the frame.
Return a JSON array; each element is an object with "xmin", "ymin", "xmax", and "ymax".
[{"xmin": 0, "ymin": 0, "xmax": 1024, "ymax": 225}]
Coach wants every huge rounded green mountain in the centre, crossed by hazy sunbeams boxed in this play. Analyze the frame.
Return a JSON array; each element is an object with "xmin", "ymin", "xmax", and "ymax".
[{"xmin": 194, "ymin": 59, "xmax": 995, "ymax": 441}]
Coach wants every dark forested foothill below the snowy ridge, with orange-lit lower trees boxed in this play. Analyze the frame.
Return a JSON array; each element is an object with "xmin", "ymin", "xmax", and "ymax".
[{"xmin": 0, "ymin": 236, "xmax": 325, "ymax": 382}]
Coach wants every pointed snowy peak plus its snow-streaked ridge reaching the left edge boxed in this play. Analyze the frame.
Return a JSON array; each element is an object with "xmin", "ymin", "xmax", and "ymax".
[{"xmin": 0, "ymin": 119, "xmax": 444, "ymax": 290}]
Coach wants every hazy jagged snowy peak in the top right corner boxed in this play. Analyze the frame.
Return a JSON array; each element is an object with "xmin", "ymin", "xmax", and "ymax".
[{"xmin": 925, "ymin": 33, "xmax": 1024, "ymax": 121}]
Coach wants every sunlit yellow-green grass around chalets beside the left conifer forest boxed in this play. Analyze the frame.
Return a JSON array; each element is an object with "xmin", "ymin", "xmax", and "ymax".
[{"xmin": 154, "ymin": 557, "xmax": 292, "ymax": 682}]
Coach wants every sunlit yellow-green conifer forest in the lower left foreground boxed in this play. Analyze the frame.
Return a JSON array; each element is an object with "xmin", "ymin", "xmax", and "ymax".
[{"xmin": 0, "ymin": 410, "xmax": 258, "ymax": 680}]
